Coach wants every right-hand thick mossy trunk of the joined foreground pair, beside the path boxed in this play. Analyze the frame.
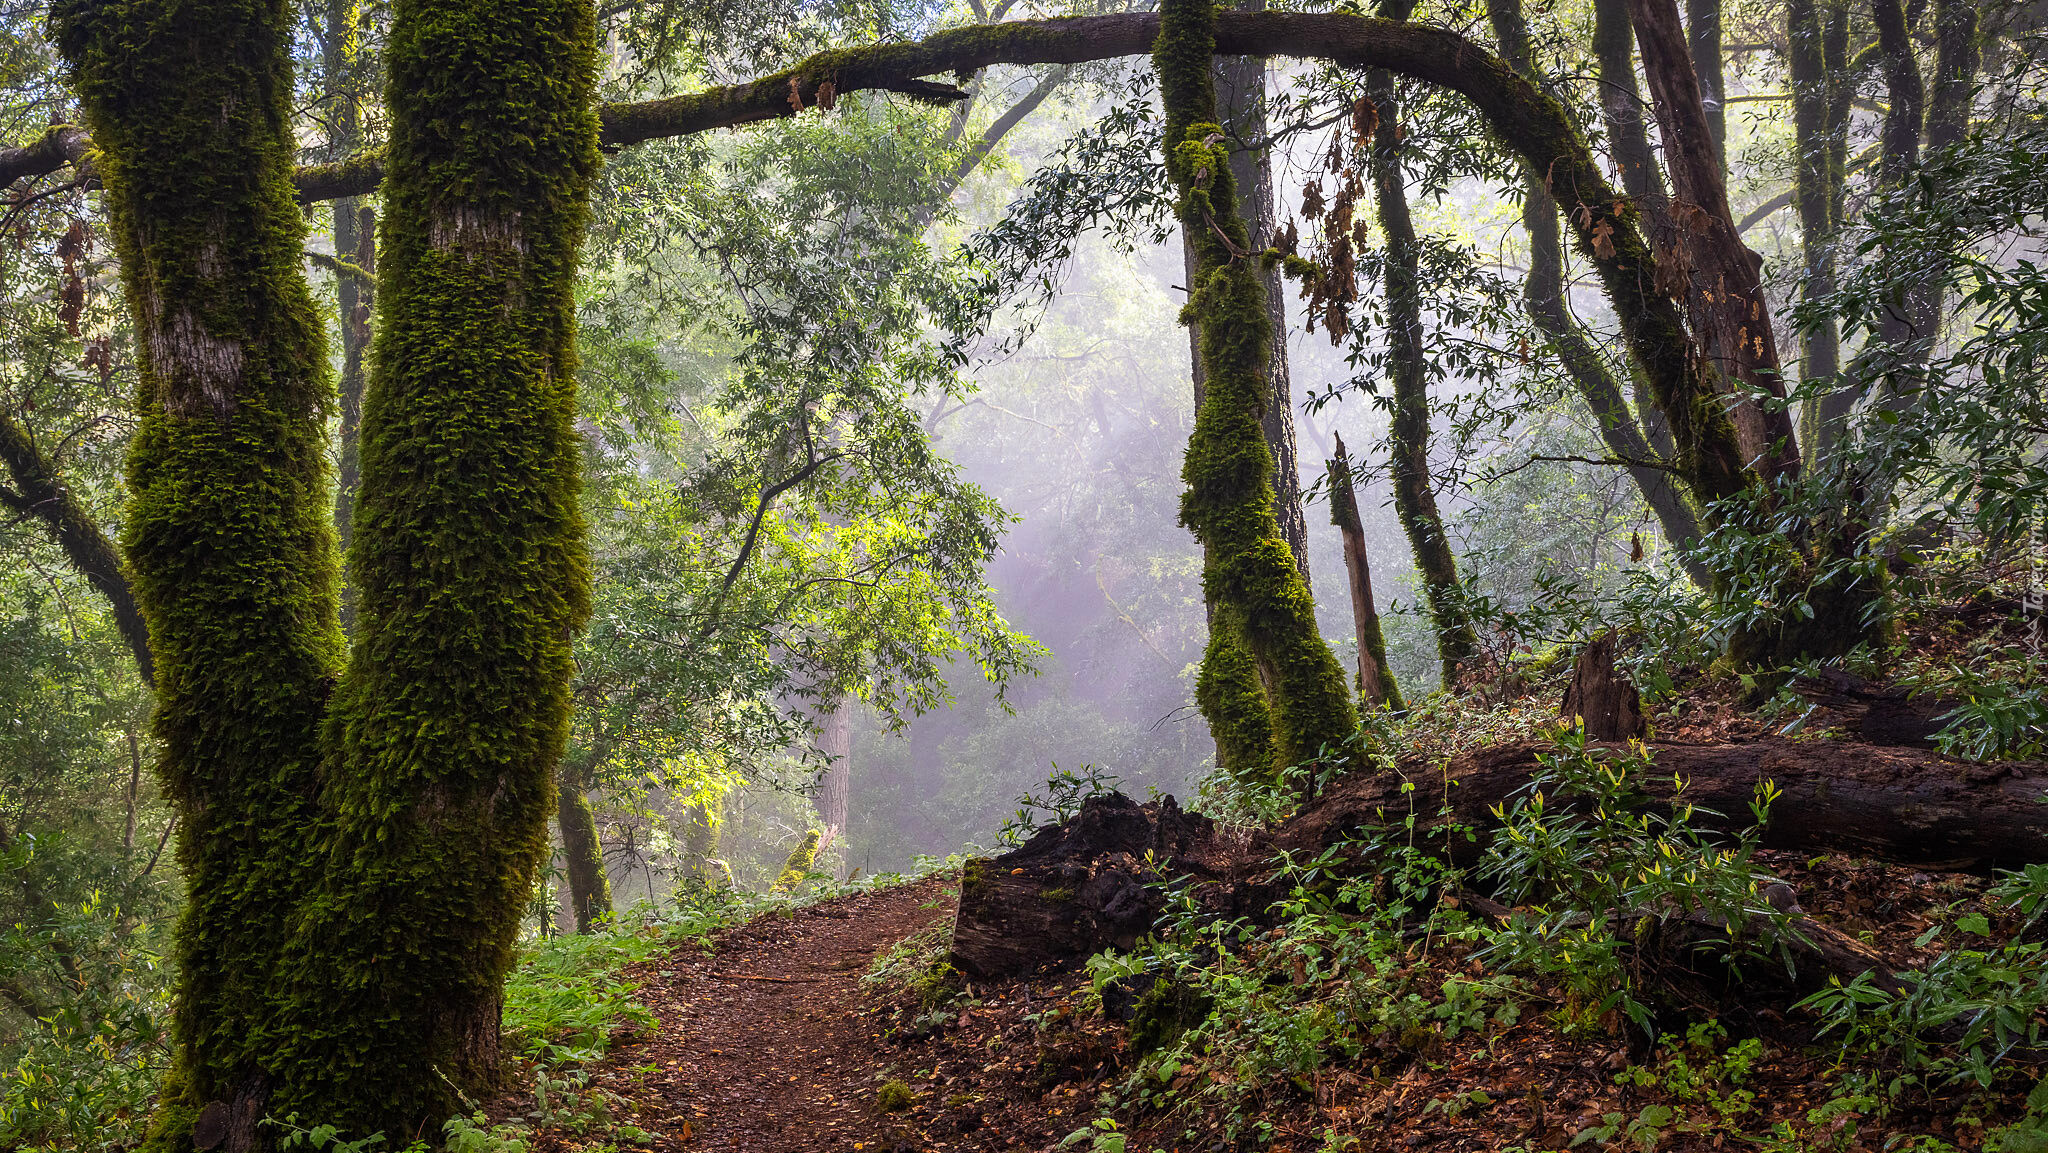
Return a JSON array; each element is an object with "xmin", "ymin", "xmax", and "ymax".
[{"xmin": 272, "ymin": 0, "xmax": 598, "ymax": 1135}]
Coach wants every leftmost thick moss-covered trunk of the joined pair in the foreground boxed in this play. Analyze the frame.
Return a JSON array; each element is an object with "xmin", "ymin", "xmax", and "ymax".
[{"xmin": 51, "ymin": 0, "xmax": 340, "ymax": 1149}]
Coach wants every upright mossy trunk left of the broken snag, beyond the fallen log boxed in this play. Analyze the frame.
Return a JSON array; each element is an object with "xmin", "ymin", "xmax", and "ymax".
[{"xmin": 1153, "ymin": 0, "xmax": 1358, "ymax": 780}]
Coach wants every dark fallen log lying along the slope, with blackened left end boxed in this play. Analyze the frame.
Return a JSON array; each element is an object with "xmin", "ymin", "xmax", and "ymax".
[{"xmin": 952, "ymin": 739, "xmax": 2048, "ymax": 979}]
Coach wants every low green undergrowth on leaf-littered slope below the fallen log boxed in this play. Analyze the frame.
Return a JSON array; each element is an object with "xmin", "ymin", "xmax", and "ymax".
[{"xmin": 978, "ymin": 731, "xmax": 2048, "ymax": 1153}]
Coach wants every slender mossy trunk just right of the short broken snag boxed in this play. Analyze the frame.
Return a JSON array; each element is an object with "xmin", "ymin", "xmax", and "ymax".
[{"xmin": 1366, "ymin": 0, "xmax": 1479, "ymax": 688}]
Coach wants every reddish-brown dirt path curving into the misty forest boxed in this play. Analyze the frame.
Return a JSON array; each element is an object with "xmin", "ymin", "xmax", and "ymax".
[{"xmin": 621, "ymin": 879, "xmax": 952, "ymax": 1153}]
